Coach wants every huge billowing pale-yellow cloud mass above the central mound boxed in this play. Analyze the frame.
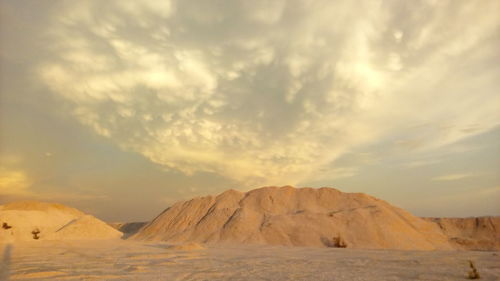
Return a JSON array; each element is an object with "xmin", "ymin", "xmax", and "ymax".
[{"xmin": 38, "ymin": 0, "xmax": 500, "ymax": 188}]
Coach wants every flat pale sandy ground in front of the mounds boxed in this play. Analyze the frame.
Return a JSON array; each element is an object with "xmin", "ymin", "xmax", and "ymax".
[{"xmin": 0, "ymin": 240, "xmax": 500, "ymax": 281}]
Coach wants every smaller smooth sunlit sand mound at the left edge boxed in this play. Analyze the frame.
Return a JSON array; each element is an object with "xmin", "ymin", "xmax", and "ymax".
[{"xmin": 0, "ymin": 201, "xmax": 122, "ymax": 242}]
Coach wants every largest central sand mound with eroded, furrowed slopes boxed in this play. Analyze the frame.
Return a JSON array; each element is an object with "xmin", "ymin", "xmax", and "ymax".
[{"xmin": 132, "ymin": 186, "xmax": 452, "ymax": 250}]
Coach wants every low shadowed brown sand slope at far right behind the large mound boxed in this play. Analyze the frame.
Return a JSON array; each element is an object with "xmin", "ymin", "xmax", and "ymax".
[{"xmin": 426, "ymin": 217, "xmax": 500, "ymax": 250}]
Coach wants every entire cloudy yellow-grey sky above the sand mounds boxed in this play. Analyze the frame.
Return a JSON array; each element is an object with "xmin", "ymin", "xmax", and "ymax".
[{"xmin": 0, "ymin": 0, "xmax": 500, "ymax": 221}]
